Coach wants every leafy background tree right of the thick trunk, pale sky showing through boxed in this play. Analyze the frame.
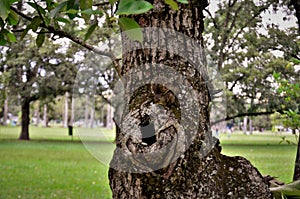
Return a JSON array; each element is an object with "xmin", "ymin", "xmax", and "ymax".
[{"xmin": 205, "ymin": 0, "xmax": 299, "ymax": 124}]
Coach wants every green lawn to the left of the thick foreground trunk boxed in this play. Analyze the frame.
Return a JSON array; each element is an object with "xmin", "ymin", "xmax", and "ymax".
[{"xmin": 0, "ymin": 127, "xmax": 112, "ymax": 199}]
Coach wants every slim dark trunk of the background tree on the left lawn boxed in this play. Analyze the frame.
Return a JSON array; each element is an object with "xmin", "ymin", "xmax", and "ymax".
[{"xmin": 19, "ymin": 99, "xmax": 30, "ymax": 140}]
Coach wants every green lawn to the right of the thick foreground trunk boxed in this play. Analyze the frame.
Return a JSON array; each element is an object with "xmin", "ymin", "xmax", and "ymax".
[{"xmin": 220, "ymin": 134, "xmax": 297, "ymax": 183}]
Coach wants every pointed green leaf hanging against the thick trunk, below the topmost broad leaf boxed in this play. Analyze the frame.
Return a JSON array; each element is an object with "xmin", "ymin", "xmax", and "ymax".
[{"xmin": 119, "ymin": 17, "xmax": 143, "ymax": 42}]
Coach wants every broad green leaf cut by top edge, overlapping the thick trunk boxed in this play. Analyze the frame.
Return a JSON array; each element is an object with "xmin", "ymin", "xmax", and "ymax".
[{"xmin": 116, "ymin": 0, "xmax": 153, "ymax": 15}]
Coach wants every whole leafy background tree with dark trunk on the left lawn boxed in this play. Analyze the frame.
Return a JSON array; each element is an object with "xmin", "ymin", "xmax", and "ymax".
[{"xmin": 4, "ymin": 36, "xmax": 76, "ymax": 140}]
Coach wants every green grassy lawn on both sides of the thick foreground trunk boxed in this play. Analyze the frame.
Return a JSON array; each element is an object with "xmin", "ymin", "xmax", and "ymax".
[{"xmin": 0, "ymin": 127, "xmax": 296, "ymax": 199}]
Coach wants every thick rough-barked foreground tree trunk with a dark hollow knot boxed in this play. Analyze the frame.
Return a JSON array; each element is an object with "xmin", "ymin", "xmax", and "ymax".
[{"xmin": 109, "ymin": 0, "xmax": 271, "ymax": 199}]
